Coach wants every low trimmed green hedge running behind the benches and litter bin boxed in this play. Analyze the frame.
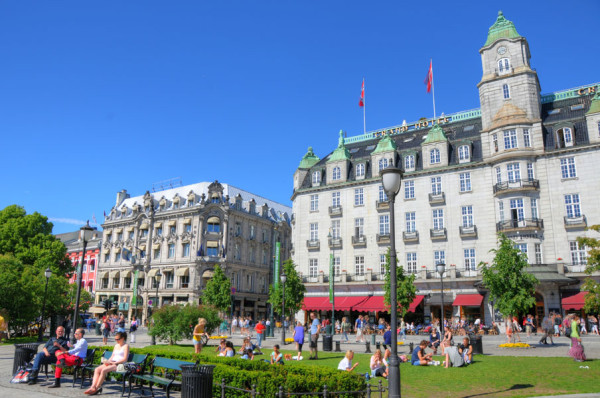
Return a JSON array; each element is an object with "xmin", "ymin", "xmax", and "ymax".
[{"xmin": 91, "ymin": 347, "xmax": 367, "ymax": 398}]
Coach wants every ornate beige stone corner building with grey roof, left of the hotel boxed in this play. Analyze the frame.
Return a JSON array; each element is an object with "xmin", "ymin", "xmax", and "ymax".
[{"xmin": 95, "ymin": 181, "xmax": 291, "ymax": 320}]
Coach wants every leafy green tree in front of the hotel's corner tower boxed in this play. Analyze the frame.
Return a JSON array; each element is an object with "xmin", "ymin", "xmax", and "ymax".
[{"xmin": 479, "ymin": 233, "xmax": 538, "ymax": 317}]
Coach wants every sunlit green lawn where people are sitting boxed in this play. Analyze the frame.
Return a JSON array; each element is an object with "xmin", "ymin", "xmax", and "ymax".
[{"xmin": 152, "ymin": 345, "xmax": 600, "ymax": 397}]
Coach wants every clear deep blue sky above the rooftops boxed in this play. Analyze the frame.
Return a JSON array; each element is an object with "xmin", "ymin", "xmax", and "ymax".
[{"xmin": 0, "ymin": 0, "xmax": 600, "ymax": 233}]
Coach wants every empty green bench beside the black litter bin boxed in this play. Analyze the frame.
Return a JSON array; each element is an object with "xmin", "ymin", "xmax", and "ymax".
[{"xmin": 128, "ymin": 357, "xmax": 195, "ymax": 398}]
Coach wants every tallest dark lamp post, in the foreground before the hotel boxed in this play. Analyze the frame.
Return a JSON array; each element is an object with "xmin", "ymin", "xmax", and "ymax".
[{"xmin": 380, "ymin": 167, "xmax": 402, "ymax": 398}]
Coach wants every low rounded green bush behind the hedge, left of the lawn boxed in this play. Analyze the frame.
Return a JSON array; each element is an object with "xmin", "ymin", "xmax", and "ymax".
[{"xmin": 148, "ymin": 304, "xmax": 221, "ymax": 345}]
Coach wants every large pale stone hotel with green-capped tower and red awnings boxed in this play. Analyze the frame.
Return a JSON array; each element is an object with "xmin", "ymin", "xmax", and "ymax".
[{"xmin": 292, "ymin": 13, "xmax": 600, "ymax": 323}]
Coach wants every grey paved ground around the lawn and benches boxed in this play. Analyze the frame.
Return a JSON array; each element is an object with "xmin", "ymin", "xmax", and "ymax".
[{"xmin": 0, "ymin": 329, "xmax": 600, "ymax": 398}]
